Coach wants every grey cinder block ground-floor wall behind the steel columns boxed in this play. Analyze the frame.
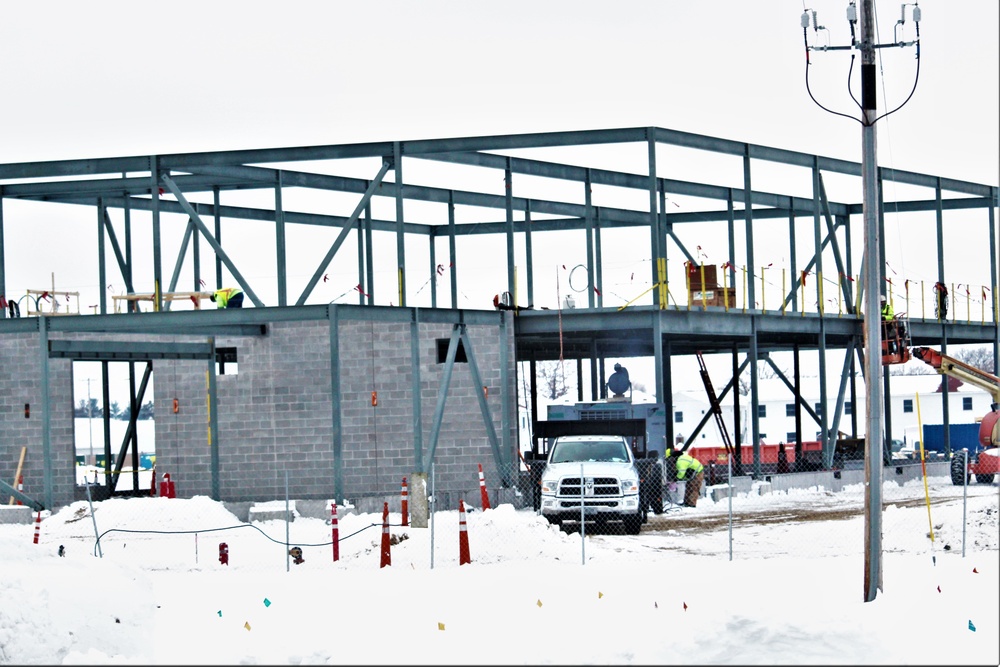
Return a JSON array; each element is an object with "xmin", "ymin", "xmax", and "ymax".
[{"xmin": 0, "ymin": 310, "xmax": 517, "ymax": 506}]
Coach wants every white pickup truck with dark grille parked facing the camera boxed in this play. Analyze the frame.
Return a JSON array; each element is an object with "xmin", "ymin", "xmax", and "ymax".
[{"xmin": 539, "ymin": 435, "xmax": 646, "ymax": 535}]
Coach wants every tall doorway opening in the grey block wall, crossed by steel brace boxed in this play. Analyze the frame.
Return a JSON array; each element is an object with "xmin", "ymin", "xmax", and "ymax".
[{"xmin": 72, "ymin": 360, "xmax": 156, "ymax": 497}]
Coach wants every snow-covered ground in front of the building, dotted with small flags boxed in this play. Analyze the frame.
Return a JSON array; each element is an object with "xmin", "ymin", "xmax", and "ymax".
[{"xmin": 0, "ymin": 478, "xmax": 1000, "ymax": 665}]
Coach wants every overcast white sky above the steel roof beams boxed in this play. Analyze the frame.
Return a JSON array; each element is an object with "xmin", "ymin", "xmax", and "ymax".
[{"xmin": 0, "ymin": 0, "xmax": 1000, "ymax": 396}]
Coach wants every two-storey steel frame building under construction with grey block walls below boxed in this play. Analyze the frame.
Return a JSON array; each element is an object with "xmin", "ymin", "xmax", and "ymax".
[{"xmin": 0, "ymin": 127, "xmax": 1000, "ymax": 507}]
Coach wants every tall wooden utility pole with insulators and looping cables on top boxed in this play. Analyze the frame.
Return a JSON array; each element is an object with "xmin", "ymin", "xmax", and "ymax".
[{"xmin": 801, "ymin": 0, "xmax": 920, "ymax": 602}]
